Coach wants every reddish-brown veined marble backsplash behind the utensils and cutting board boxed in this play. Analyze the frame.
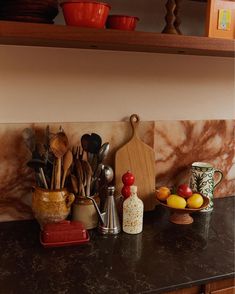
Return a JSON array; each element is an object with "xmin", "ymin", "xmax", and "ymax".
[{"xmin": 0, "ymin": 120, "xmax": 235, "ymax": 221}]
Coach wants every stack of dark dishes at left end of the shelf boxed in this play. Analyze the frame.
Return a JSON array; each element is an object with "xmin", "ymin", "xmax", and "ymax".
[{"xmin": 0, "ymin": 0, "xmax": 59, "ymax": 23}]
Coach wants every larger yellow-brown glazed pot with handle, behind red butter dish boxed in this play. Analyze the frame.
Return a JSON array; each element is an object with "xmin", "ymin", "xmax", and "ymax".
[{"xmin": 32, "ymin": 187, "xmax": 75, "ymax": 227}]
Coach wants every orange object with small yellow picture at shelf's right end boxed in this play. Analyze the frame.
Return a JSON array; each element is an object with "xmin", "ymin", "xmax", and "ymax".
[{"xmin": 206, "ymin": 0, "xmax": 235, "ymax": 39}]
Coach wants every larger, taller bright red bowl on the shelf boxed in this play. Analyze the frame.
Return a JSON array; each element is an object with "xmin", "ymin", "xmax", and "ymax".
[{"xmin": 61, "ymin": 1, "xmax": 111, "ymax": 28}]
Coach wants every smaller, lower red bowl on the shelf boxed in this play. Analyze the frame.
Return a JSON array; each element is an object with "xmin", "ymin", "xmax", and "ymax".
[{"xmin": 106, "ymin": 15, "xmax": 139, "ymax": 31}]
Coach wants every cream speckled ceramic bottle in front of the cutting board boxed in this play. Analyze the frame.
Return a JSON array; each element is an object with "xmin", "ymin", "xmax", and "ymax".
[{"xmin": 122, "ymin": 186, "xmax": 144, "ymax": 234}]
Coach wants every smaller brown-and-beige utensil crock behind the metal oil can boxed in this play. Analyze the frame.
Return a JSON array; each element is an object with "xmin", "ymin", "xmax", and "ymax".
[{"xmin": 72, "ymin": 195, "xmax": 100, "ymax": 230}]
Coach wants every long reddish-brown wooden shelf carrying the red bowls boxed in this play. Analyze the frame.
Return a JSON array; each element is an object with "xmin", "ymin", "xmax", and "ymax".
[{"xmin": 0, "ymin": 21, "xmax": 235, "ymax": 57}]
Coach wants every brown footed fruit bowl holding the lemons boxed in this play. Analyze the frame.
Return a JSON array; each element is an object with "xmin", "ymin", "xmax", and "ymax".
[{"xmin": 159, "ymin": 196, "xmax": 210, "ymax": 225}]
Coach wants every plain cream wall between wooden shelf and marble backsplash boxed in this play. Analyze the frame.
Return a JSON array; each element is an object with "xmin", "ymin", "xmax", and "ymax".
[{"xmin": 0, "ymin": 0, "xmax": 235, "ymax": 122}]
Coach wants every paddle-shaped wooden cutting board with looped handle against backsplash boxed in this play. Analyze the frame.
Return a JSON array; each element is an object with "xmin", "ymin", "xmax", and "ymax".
[{"xmin": 115, "ymin": 114, "xmax": 156, "ymax": 211}]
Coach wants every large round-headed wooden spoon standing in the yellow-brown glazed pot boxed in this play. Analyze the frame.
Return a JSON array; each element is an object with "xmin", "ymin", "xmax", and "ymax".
[{"xmin": 50, "ymin": 132, "xmax": 69, "ymax": 189}]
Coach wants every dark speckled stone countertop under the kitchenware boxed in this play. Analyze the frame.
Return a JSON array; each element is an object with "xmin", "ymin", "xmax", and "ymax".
[{"xmin": 0, "ymin": 197, "xmax": 234, "ymax": 294}]
